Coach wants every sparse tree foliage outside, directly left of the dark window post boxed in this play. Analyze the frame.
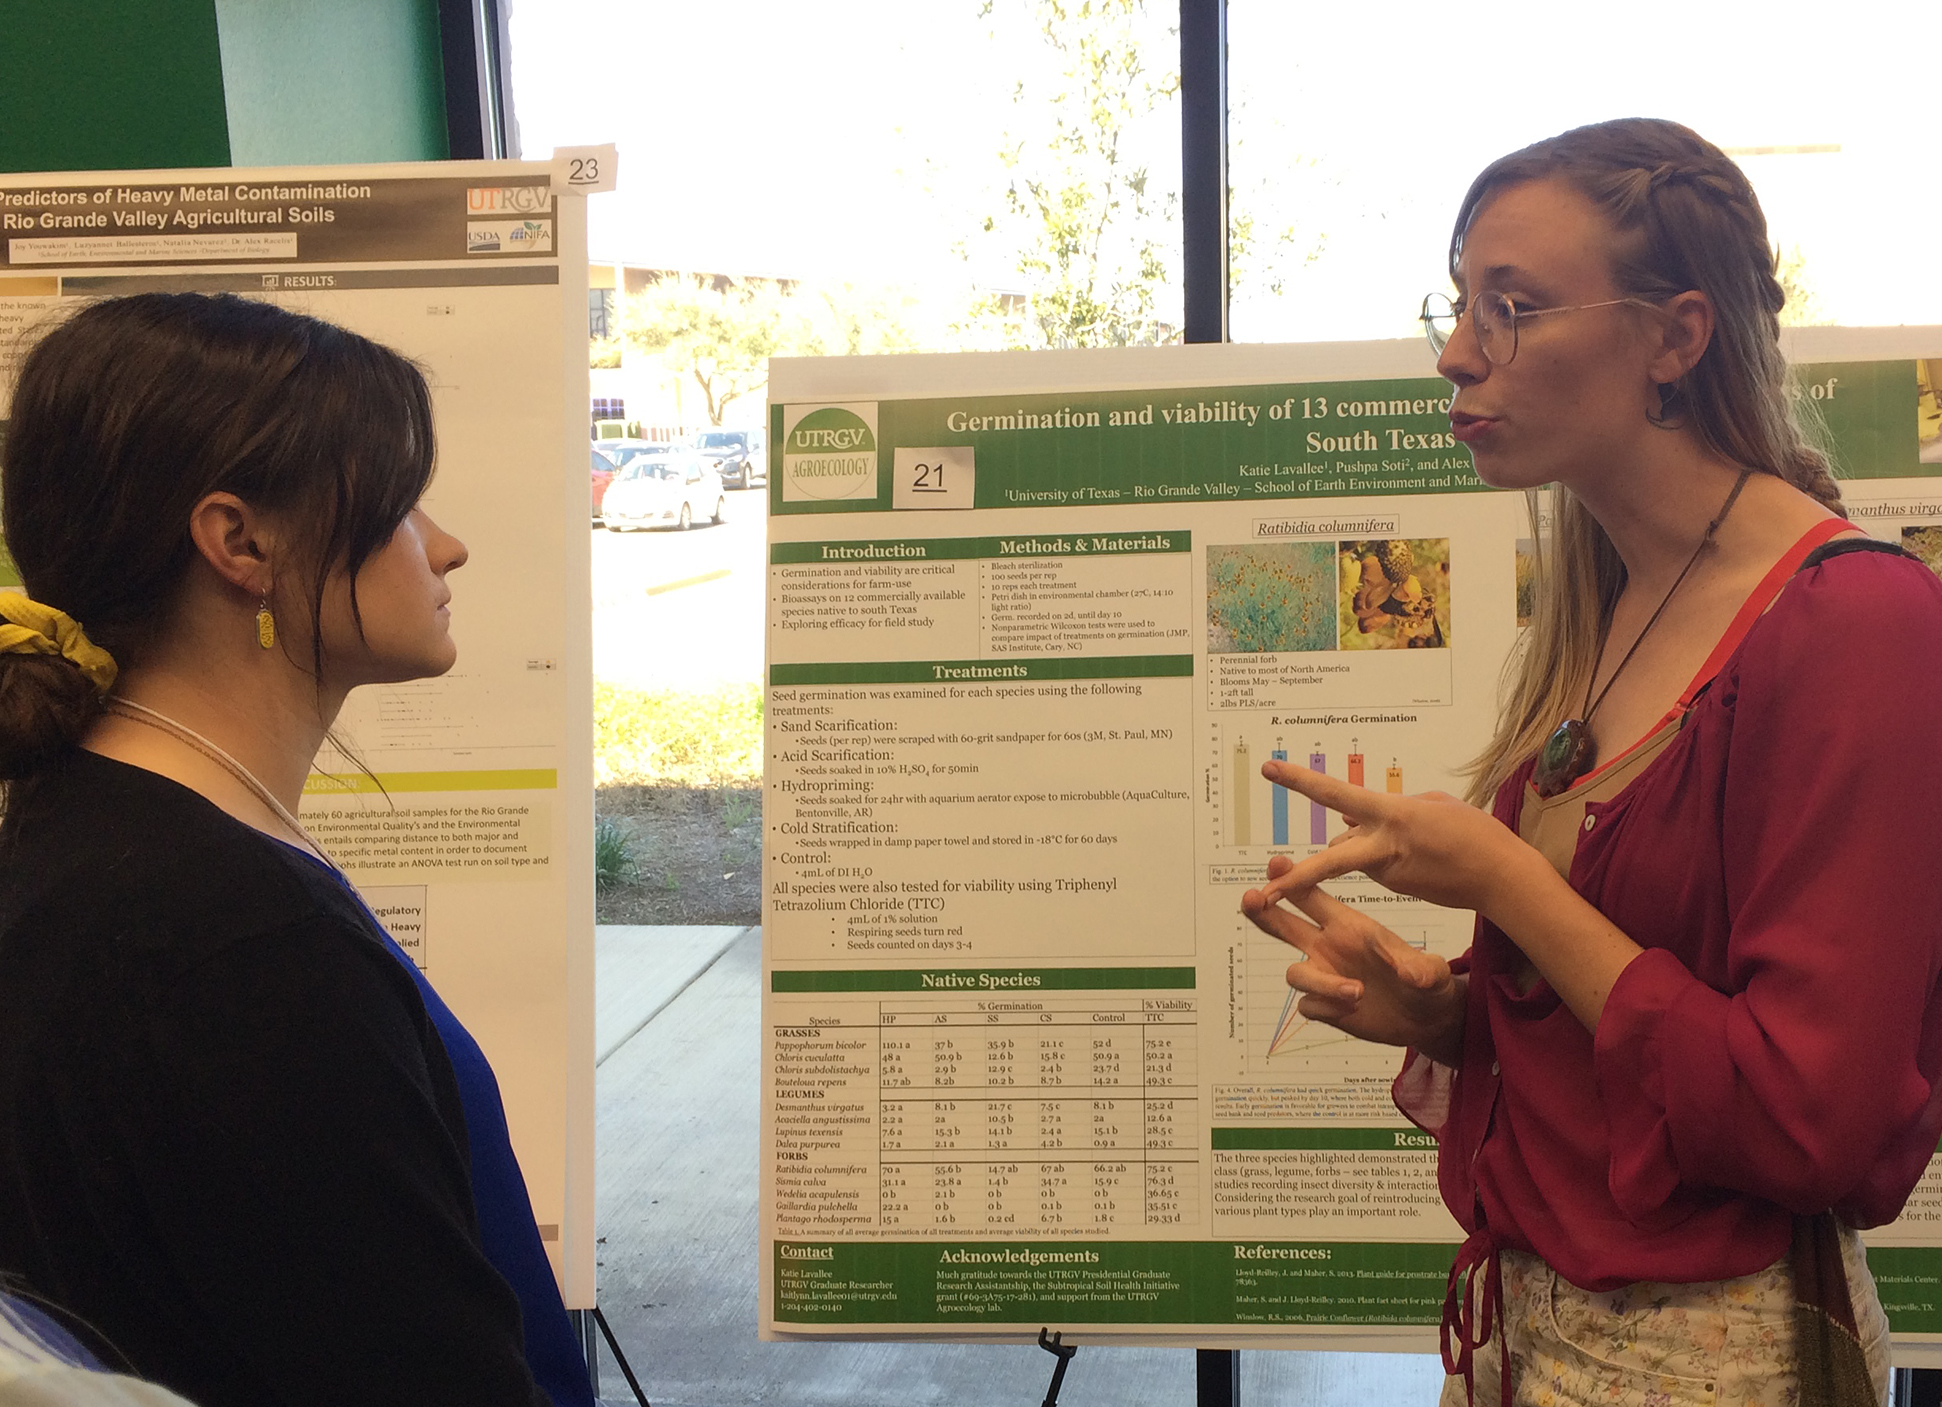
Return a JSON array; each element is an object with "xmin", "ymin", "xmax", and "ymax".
[{"xmin": 967, "ymin": 0, "xmax": 1181, "ymax": 347}]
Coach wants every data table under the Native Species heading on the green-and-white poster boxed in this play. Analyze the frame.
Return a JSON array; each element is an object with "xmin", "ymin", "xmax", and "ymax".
[{"xmin": 773, "ymin": 994, "xmax": 1202, "ymax": 1234}]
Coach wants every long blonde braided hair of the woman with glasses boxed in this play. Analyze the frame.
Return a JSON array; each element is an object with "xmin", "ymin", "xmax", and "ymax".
[{"xmin": 1449, "ymin": 118, "xmax": 1843, "ymax": 805}]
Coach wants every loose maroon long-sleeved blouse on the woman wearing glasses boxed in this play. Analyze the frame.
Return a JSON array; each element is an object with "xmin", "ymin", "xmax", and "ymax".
[{"xmin": 1394, "ymin": 549, "xmax": 1942, "ymax": 1291}]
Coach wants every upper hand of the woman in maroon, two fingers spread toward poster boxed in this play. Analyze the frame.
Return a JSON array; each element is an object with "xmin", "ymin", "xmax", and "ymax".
[{"xmin": 1260, "ymin": 763, "xmax": 1542, "ymax": 912}]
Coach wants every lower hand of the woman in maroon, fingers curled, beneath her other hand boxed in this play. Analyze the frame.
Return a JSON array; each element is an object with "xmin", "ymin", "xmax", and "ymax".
[{"xmin": 1241, "ymin": 856, "xmax": 1464, "ymax": 1063}]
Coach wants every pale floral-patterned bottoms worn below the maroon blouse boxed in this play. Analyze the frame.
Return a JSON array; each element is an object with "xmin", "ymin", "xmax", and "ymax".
[{"xmin": 1441, "ymin": 1227, "xmax": 1890, "ymax": 1407}]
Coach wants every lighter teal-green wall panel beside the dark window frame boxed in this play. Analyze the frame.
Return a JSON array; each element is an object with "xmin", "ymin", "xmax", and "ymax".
[{"xmin": 216, "ymin": 0, "xmax": 451, "ymax": 167}]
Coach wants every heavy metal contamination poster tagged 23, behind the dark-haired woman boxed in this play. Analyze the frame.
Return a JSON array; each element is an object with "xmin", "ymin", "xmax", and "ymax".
[{"xmin": 0, "ymin": 161, "xmax": 594, "ymax": 1306}]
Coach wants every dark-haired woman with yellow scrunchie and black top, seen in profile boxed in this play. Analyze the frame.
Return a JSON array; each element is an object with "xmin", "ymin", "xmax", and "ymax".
[{"xmin": 0, "ymin": 293, "xmax": 592, "ymax": 1407}]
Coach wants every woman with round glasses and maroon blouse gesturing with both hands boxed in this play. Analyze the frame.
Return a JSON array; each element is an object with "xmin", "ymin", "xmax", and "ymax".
[{"xmin": 1243, "ymin": 120, "xmax": 1942, "ymax": 1403}]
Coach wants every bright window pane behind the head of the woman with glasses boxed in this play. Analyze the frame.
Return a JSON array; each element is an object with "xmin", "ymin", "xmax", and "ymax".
[{"xmin": 1227, "ymin": 0, "xmax": 1942, "ymax": 342}]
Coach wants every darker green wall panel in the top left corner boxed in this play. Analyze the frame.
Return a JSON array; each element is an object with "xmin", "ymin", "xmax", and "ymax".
[{"xmin": 0, "ymin": 0, "xmax": 229, "ymax": 171}]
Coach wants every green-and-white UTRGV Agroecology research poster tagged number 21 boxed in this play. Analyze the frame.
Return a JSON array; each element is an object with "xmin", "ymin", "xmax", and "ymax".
[{"xmin": 761, "ymin": 330, "xmax": 1942, "ymax": 1360}]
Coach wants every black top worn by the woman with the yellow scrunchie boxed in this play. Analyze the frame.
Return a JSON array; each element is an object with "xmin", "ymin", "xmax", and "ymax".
[{"xmin": 0, "ymin": 751, "xmax": 546, "ymax": 1407}]
